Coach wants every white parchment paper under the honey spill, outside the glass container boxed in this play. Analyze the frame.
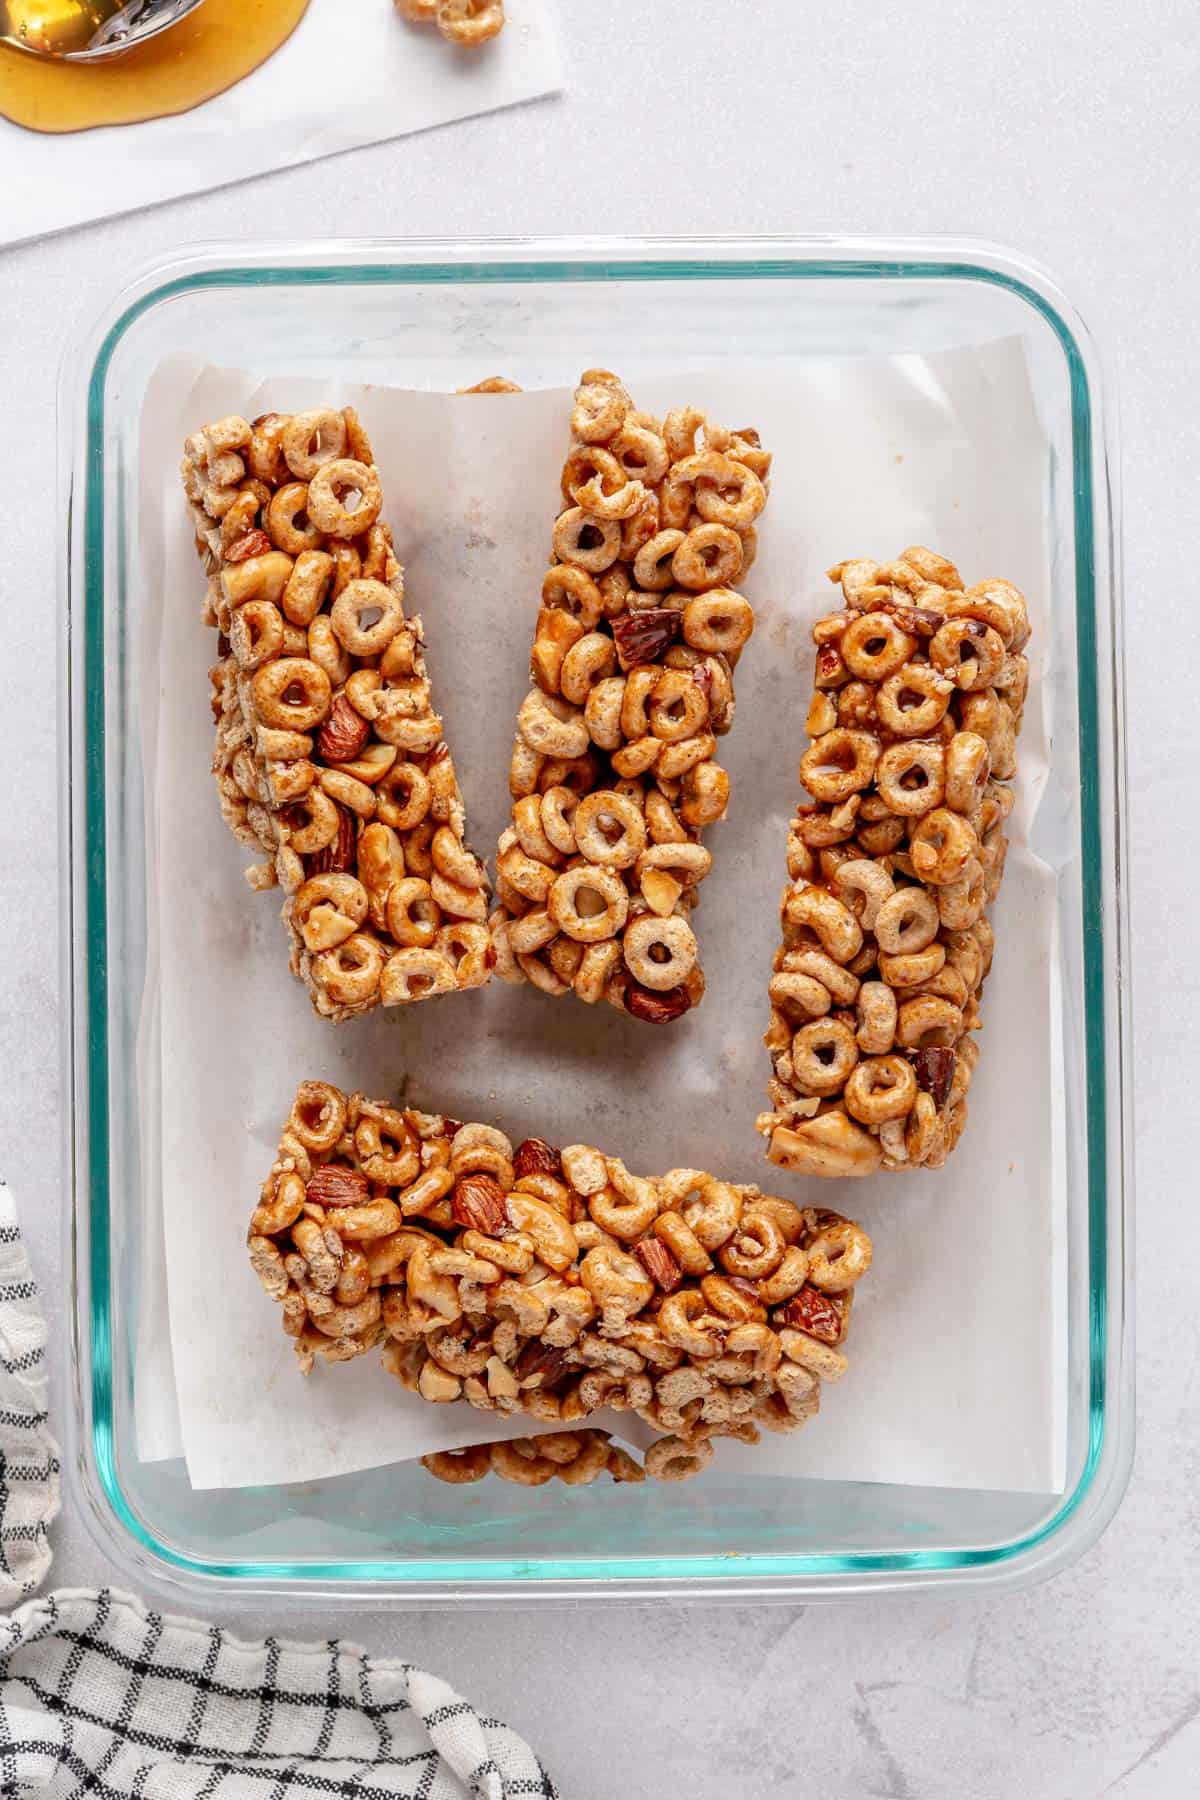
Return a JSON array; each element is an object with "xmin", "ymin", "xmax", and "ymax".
[{"xmin": 0, "ymin": 0, "xmax": 563, "ymax": 243}]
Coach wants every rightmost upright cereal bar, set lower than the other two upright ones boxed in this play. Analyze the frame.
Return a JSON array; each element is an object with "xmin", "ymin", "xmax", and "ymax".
[{"xmin": 757, "ymin": 545, "xmax": 1029, "ymax": 1177}]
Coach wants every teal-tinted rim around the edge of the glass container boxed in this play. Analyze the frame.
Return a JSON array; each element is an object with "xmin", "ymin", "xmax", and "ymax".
[{"xmin": 63, "ymin": 239, "xmax": 1132, "ymax": 1598}]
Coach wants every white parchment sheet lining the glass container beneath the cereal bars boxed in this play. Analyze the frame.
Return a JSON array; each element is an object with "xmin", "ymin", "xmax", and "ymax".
[{"xmin": 139, "ymin": 340, "xmax": 1065, "ymax": 1492}]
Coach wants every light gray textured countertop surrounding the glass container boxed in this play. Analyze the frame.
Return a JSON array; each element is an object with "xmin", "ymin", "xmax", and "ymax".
[{"xmin": 0, "ymin": 0, "xmax": 1200, "ymax": 1800}]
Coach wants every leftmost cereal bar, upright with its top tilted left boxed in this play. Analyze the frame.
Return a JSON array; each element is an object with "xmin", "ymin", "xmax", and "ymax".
[{"xmin": 182, "ymin": 407, "xmax": 495, "ymax": 1019}]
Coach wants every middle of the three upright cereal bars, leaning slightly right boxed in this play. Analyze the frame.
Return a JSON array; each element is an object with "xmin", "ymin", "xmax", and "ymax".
[{"xmin": 491, "ymin": 369, "xmax": 770, "ymax": 1024}]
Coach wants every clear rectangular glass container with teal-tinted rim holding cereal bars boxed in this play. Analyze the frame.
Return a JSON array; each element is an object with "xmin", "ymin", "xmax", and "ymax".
[{"xmin": 61, "ymin": 238, "xmax": 1133, "ymax": 1606}]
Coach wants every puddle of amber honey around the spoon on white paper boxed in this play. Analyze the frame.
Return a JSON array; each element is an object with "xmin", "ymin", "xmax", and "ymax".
[{"xmin": 0, "ymin": 0, "xmax": 308, "ymax": 131}]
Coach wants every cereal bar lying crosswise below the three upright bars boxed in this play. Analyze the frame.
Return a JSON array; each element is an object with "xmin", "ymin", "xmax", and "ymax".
[{"xmin": 248, "ymin": 1082, "xmax": 871, "ymax": 1485}]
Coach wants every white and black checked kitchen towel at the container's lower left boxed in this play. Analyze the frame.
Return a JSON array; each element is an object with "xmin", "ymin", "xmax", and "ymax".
[{"xmin": 0, "ymin": 1186, "xmax": 556, "ymax": 1800}]
